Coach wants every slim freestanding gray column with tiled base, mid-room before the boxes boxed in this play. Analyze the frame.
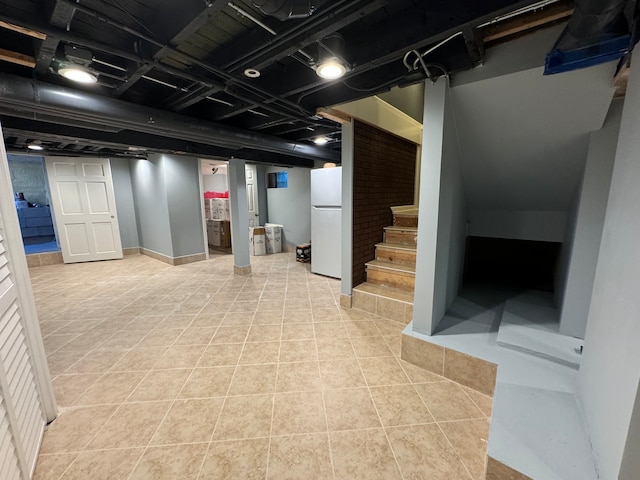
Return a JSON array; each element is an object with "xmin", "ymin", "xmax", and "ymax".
[{"xmin": 229, "ymin": 159, "xmax": 251, "ymax": 275}]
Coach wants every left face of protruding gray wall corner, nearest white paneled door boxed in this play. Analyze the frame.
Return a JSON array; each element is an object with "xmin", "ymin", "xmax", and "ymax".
[{"xmin": 131, "ymin": 155, "xmax": 173, "ymax": 257}]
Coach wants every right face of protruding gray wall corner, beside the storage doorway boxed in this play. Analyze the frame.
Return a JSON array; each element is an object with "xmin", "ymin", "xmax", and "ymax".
[{"xmin": 163, "ymin": 155, "xmax": 204, "ymax": 258}]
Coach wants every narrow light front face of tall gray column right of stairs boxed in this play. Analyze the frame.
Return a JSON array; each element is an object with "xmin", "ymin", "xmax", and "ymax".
[{"xmin": 413, "ymin": 78, "xmax": 447, "ymax": 335}]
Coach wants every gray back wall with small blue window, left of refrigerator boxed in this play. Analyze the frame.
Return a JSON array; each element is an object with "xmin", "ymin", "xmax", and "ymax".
[{"xmin": 267, "ymin": 167, "xmax": 311, "ymax": 246}]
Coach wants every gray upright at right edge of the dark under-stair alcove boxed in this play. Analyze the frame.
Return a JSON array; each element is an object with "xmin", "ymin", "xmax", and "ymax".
[{"xmin": 560, "ymin": 100, "xmax": 622, "ymax": 338}]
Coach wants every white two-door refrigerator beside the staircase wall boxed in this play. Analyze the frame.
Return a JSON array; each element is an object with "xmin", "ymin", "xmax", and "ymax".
[{"xmin": 311, "ymin": 167, "xmax": 342, "ymax": 278}]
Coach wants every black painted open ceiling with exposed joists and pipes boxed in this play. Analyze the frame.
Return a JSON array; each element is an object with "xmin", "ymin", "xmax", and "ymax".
[{"xmin": 0, "ymin": 0, "xmax": 571, "ymax": 164}]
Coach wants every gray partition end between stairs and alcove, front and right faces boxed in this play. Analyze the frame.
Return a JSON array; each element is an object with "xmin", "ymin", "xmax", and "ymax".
[{"xmin": 413, "ymin": 78, "xmax": 467, "ymax": 335}]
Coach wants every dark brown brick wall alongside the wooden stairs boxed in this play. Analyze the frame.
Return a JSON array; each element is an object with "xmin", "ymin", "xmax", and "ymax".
[{"xmin": 353, "ymin": 121, "xmax": 417, "ymax": 287}]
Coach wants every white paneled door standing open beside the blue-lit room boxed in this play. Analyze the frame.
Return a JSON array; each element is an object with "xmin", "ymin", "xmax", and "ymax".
[{"xmin": 46, "ymin": 157, "xmax": 122, "ymax": 263}]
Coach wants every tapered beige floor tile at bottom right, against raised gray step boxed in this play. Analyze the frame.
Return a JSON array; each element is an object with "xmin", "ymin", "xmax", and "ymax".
[{"xmin": 439, "ymin": 420, "xmax": 489, "ymax": 480}]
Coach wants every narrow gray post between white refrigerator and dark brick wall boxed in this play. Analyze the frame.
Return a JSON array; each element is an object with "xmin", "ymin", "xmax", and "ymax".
[{"xmin": 340, "ymin": 121, "xmax": 353, "ymax": 308}]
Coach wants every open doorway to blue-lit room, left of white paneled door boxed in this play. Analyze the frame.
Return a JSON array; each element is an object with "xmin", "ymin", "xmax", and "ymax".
[{"xmin": 7, "ymin": 155, "xmax": 60, "ymax": 255}]
